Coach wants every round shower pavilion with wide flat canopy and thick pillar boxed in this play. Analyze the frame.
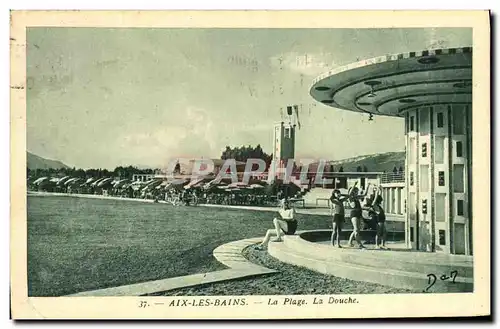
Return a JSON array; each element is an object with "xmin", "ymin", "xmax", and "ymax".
[{"xmin": 310, "ymin": 47, "xmax": 473, "ymax": 255}]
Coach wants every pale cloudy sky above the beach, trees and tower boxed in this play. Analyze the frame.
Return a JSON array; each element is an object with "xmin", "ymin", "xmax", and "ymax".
[{"xmin": 26, "ymin": 28, "xmax": 472, "ymax": 169}]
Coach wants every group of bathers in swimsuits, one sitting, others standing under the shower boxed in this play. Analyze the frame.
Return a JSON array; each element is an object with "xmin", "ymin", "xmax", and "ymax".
[{"xmin": 257, "ymin": 184, "xmax": 387, "ymax": 249}]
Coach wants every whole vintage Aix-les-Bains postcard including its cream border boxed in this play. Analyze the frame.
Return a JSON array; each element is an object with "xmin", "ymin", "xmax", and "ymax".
[{"xmin": 10, "ymin": 11, "xmax": 491, "ymax": 319}]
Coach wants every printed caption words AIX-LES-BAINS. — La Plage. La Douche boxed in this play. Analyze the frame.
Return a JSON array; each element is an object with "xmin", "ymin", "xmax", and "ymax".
[{"xmin": 166, "ymin": 296, "xmax": 359, "ymax": 307}]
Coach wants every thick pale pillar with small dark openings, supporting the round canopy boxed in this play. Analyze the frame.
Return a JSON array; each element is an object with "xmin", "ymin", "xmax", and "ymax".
[{"xmin": 406, "ymin": 104, "xmax": 472, "ymax": 255}]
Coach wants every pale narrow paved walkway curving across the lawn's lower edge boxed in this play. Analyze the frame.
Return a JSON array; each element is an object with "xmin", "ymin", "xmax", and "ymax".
[{"xmin": 65, "ymin": 238, "xmax": 277, "ymax": 297}]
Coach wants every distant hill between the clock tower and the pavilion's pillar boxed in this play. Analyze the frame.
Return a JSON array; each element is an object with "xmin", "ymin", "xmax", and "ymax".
[{"xmin": 328, "ymin": 152, "xmax": 405, "ymax": 172}]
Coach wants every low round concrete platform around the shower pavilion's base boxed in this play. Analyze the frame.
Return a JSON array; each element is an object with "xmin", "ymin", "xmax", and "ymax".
[{"xmin": 268, "ymin": 230, "xmax": 474, "ymax": 292}]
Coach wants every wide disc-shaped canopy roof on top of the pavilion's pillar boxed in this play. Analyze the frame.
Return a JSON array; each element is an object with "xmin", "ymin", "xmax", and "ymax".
[{"xmin": 310, "ymin": 47, "xmax": 472, "ymax": 116}]
